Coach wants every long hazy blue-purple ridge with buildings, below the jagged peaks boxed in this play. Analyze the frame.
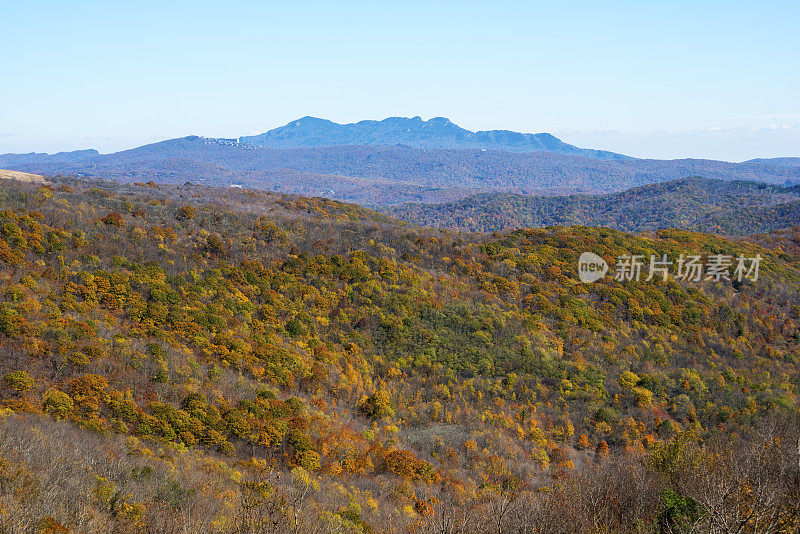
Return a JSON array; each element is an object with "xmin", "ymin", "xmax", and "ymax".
[{"xmin": 0, "ymin": 136, "xmax": 800, "ymax": 206}]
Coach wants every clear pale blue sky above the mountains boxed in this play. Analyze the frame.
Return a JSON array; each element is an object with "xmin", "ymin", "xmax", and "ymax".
[{"xmin": 0, "ymin": 0, "xmax": 800, "ymax": 161}]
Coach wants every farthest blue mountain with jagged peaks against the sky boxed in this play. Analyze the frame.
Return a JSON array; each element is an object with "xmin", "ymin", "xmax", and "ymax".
[{"xmin": 239, "ymin": 117, "xmax": 632, "ymax": 160}]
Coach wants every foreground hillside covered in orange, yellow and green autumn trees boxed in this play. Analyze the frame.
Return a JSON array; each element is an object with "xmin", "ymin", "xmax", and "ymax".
[{"xmin": 0, "ymin": 178, "xmax": 800, "ymax": 533}]
